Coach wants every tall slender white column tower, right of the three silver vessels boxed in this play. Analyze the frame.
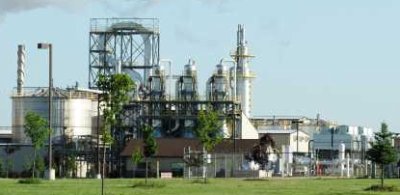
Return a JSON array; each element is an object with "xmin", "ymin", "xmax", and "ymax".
[{"xmin": 231, "ymin": 24, "xmax": 255, "ymax": 117}]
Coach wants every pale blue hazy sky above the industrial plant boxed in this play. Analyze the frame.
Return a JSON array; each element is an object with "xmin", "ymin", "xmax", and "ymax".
[{"xmin": 0, "ymin": 0, "xmax": 400, "ymax": 132}]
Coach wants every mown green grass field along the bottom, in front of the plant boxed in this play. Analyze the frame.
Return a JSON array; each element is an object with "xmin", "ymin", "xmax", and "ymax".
[{"xmin": 0, "ymin": 178, "xmax": 400, "ymax": 195}]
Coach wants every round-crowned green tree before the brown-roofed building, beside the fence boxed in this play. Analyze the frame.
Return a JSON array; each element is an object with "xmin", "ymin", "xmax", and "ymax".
[{"xmin": 194, "ymin": 107, "xmax": 223, "ymax": 183}]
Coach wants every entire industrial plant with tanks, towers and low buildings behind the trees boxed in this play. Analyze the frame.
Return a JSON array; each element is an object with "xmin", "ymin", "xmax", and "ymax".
[{"xmin": 0, "ymin": 18, "xmax": 382, "ymax": 177}]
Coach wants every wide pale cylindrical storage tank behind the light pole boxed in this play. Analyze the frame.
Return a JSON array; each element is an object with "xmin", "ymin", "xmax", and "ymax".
[{"xmin": 11, "ymin": 88, "xmax": 98, "ymax": 143}]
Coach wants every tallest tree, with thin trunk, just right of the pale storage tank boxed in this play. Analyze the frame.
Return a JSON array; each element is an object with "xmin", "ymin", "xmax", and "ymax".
[{"xmin": 96, "ymin": 74, "xmax": 135, "ymax": 194}]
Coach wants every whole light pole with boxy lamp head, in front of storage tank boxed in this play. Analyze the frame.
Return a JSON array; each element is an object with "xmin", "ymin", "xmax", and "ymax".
[{"xmin": 37, "ymin": 43, "xmax": 55, "ymax": 180}]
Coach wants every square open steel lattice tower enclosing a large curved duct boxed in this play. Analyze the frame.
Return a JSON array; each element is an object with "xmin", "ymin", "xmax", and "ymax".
[{"xmin": 89, "ymin": 18, "xmax": 160, "ymax": 88}]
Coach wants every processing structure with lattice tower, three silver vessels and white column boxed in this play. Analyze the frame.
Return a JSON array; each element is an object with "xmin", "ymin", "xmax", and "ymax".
[{"xmin": 89, "ymin": 18, "xmax": 258, "ymax": 142}]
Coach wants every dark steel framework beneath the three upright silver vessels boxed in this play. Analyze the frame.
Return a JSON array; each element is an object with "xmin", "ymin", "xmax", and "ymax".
[{"xmin": 120, "ymin": 100, "xmax": 241, "ymax": 140}]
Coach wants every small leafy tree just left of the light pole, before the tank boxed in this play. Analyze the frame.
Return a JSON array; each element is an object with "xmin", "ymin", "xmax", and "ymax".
[{"xmin": 24, "ymin": 112, "xmax": 50, "ymax": 178}]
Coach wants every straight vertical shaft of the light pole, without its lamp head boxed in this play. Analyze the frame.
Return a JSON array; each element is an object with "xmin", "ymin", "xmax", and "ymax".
[{"xmin": 49, "ymin": 44, "xmax": 53, "ymax": 180}]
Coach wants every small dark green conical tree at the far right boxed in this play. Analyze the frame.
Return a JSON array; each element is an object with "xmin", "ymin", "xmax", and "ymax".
[{"xmin": 367, "ymin": 123, "xmax": 396, "ymax": 187}]
